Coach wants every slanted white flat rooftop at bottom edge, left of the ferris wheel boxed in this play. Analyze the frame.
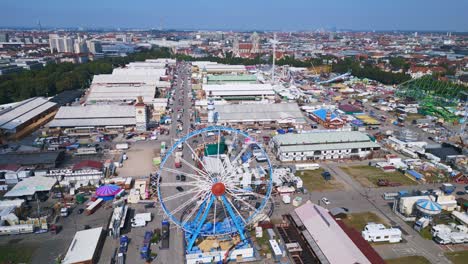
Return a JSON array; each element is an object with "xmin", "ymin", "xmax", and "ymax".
[{"xmin": 62, "ymin": 227, "xmax": 102, "ymax": 264}]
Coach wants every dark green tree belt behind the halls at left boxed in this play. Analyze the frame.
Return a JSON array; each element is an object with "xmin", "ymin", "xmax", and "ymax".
[{"xmin": 0, "ymin": 48, "xmax": 171, "ymax": 104}]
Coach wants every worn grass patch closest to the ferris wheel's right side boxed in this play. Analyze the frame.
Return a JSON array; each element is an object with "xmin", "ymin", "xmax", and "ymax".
[{"xmin": 296, "ymin": 168, "xmax": 344, "ymax": 192}]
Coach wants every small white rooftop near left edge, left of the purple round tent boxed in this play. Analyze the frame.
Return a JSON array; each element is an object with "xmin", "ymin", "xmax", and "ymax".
[{"xmin": 4, "ymin": 176, "xmax": 57, "ymax": 197}]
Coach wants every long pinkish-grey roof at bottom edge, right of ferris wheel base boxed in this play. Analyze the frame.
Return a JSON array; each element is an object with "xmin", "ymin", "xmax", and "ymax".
[{"xmin": 294, "ymin": 201, "xmax": 371, "ymax": 264}]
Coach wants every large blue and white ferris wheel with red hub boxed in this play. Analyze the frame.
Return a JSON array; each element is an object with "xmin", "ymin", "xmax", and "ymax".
[{"xmin": 153, "ymin": 126, "xmax": 272, "ymax": 252}]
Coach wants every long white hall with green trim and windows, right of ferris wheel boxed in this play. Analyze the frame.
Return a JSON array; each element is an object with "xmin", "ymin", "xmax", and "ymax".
[{"xmin": 270, "ymin": 131, "xmax": 380, "ymax": 161}]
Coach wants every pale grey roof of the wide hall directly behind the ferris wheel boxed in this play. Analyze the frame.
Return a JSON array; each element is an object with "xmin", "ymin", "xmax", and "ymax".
[{"xmin": 215, "ymin": 103, "xmax": 305, "ymax": 123}]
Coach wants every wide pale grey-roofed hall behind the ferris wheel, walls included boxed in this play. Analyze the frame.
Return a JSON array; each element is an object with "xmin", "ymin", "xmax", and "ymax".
[{"xmin": 214, "ymin": 103, "xmax": 306, "ymax": 128}]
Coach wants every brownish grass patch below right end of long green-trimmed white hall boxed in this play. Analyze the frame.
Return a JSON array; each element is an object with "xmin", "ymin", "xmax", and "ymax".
[{"xmin": 340, "ymin": 165, "xmax": 416, "ymax": 187}]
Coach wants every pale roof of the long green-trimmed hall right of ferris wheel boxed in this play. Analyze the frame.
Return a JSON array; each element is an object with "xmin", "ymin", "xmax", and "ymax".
[{"xmin": 273, "ymin": 131, "xmax": 370, "ymax": 146}]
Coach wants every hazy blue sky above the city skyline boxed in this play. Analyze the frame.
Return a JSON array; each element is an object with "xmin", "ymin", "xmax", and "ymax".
[{"xmin": 0, "ymin": 0, "xmax": 468, "ymax": 31}]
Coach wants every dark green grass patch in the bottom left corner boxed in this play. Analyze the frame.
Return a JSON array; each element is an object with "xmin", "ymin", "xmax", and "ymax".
[{"xmin": 0, "ymin": 244, "xmax": 37, "ymax": 264}]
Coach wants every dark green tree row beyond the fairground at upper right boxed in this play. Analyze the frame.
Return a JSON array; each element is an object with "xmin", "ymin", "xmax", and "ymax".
[{"xmin": 332, "ymin": 58, "xmax": 411, "ymax": 84}]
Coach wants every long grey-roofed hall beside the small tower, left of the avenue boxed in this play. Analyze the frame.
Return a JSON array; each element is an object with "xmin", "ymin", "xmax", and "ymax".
[{"xmin": 49, "ymin": 105, "xmax": 137, "ymax": 136}]
